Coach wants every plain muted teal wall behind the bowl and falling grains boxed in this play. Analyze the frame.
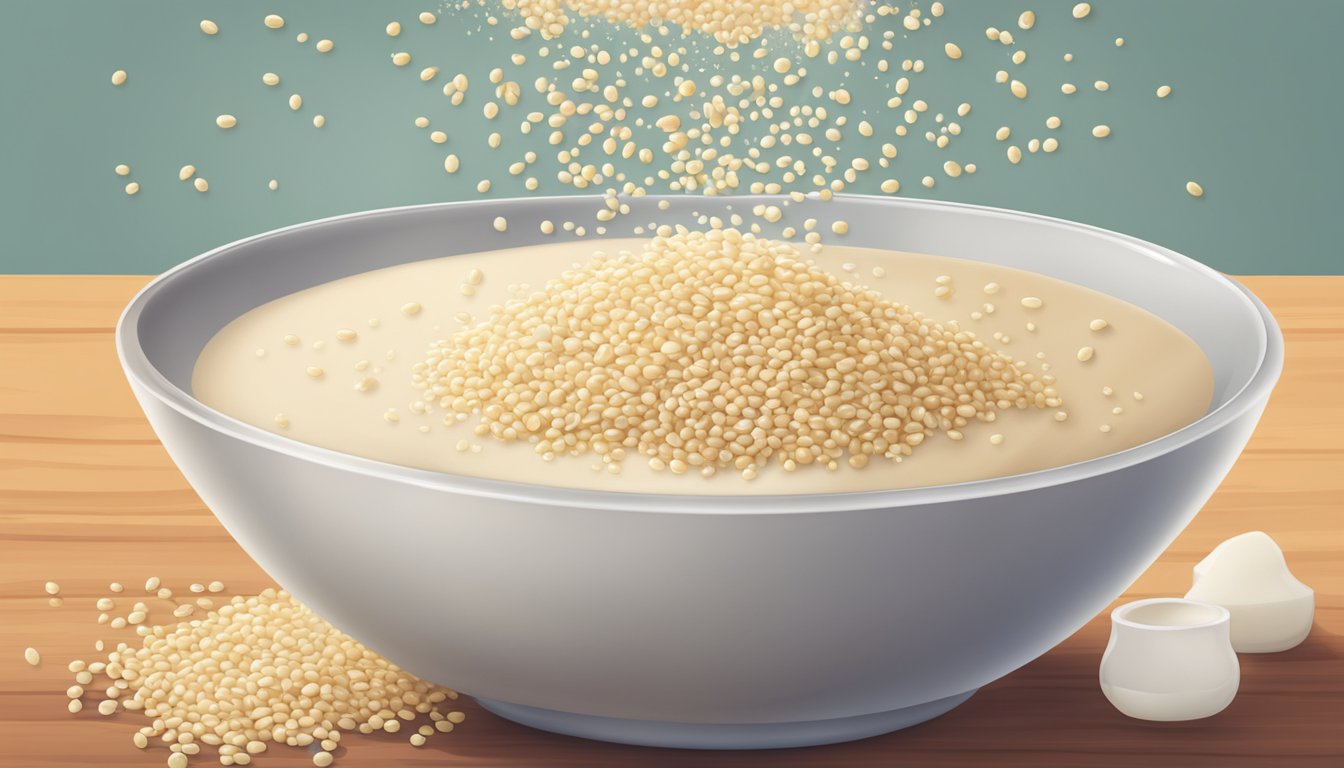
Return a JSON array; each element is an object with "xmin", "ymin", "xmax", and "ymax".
[{"xmin": 0, "ymin": 0, "xmax": 1344, "ymax": 274}]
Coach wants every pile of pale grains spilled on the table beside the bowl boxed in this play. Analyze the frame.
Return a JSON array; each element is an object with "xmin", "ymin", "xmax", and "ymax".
[{"xmin": 60, "ymin": 580, "xmax": 465, "ymax": 768}]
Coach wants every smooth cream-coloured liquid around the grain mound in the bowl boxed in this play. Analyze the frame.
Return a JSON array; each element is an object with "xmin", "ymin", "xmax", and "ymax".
[{"xmin": 192, "ymin": 239, "xmax": 1214, "ymax": 495}]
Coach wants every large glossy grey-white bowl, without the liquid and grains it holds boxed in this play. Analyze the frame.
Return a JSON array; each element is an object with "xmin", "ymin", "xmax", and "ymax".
[{"xmin": 117, "ymin": 196, "xmax": 1282, "ymax": 748}]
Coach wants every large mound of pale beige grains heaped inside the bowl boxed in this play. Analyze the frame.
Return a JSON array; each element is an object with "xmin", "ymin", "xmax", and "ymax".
[{"xmin": 413, "ymin": 227, "xmax": 1060, "ymax": 479}]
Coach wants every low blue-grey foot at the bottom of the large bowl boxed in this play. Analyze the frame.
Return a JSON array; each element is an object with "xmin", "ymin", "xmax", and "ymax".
[{"xmin": 476, "ymin": 690, "xmax": 976, "ymax": 749}]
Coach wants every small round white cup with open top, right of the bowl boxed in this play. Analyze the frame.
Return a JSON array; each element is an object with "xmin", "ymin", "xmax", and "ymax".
[{"xmin": 1101, "ymin": 597, "xmax": 1242, "ymax": 721}]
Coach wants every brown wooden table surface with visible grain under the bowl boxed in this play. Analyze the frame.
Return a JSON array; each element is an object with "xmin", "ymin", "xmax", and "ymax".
[{"xmin": 0, "ymin": 276, "xmax": 1344, "ymax": 768}]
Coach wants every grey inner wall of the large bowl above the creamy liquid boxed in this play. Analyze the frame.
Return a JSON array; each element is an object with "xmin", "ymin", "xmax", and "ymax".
[{"xmin": 118, "ymin": 195, "xmax": 1273, "ymax": 489}]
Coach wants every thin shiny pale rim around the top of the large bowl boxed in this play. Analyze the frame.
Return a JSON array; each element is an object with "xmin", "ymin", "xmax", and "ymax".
[{"xmin": 114, "ymin": 194, "xmax": 1284, "ymax": 514}]
